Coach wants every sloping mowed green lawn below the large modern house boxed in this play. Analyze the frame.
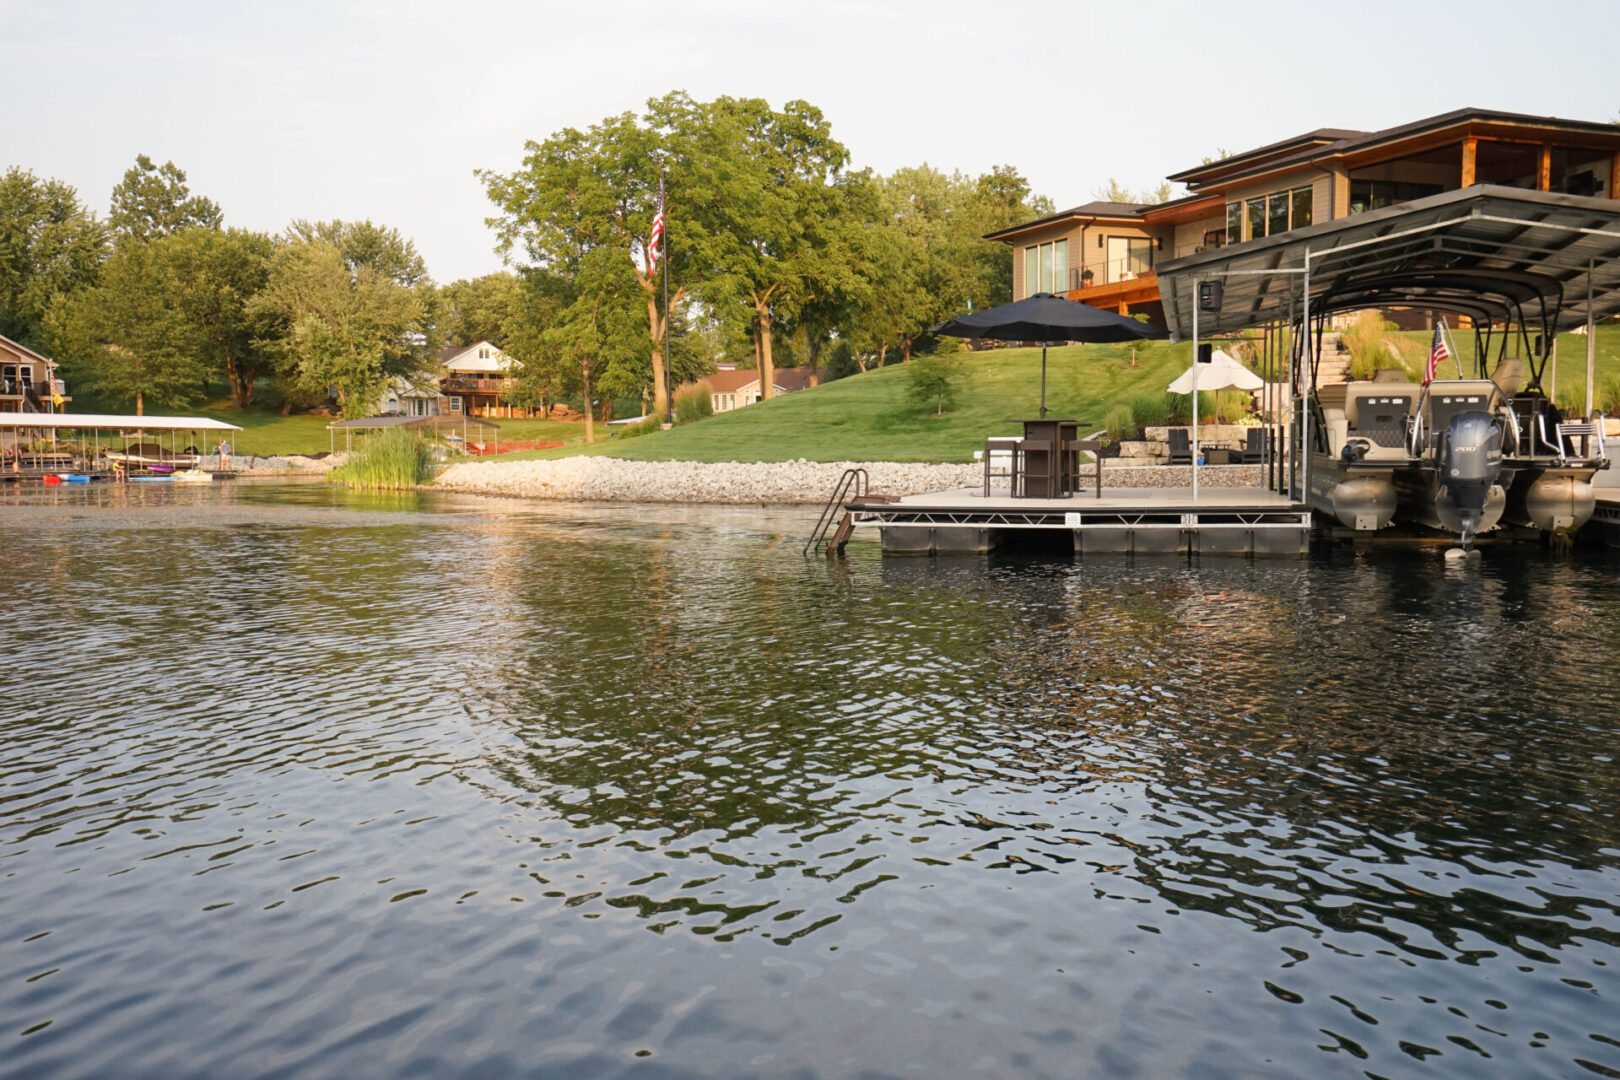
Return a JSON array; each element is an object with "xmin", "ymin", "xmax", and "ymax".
[{"xmin": 489, "ymin": 343, "xmax": 1191, "ymax": 461}]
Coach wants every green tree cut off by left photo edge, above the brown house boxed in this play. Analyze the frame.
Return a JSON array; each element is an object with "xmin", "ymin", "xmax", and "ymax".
[{"xmin": 0, "ymin": 167, "xmax": 107, "ymax": 348}]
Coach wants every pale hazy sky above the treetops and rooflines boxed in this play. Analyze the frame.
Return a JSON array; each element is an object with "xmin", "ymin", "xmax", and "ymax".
[{"xmin": 0, "ymin": 0, "xmax": 1620, "ymax": 282}]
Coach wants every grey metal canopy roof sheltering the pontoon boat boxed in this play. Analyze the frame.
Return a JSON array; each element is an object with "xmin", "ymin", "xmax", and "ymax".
[{"xmin": 1158, "ymin": 185, "xmax": 1620, "ymax": 340}]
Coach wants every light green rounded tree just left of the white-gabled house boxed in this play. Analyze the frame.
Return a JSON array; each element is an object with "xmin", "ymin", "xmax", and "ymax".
[{"xmin": 248, "ymin": 222, "xmax": 436, "ymax": 416}]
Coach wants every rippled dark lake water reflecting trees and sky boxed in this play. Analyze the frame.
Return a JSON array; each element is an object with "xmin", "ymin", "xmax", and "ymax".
[{"xmin": 0, "ymin": 483, "xmax": 1620, "ymax": 1080}]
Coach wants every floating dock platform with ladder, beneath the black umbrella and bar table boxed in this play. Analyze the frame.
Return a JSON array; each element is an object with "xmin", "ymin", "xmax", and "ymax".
[{"xmin": 849, "ymin": 487, "xmax": 1312, "ymax": 555}]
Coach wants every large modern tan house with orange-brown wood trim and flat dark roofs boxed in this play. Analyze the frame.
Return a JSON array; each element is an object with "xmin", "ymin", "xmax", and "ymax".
[{"xmin": 987, "ymin": 108, "xmax": 1620, "ymax": 327}]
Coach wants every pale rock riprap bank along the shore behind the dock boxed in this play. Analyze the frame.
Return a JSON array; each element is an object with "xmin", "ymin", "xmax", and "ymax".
[{"xmin": 434, "ymin": 457, "xmax": 1264, "ymax": 504}]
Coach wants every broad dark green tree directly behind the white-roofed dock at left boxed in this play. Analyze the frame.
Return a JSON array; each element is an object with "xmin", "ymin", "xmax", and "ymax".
[{"xmin": 45, "ymin": 238, "xmax": 209, "ymax": 416}]
